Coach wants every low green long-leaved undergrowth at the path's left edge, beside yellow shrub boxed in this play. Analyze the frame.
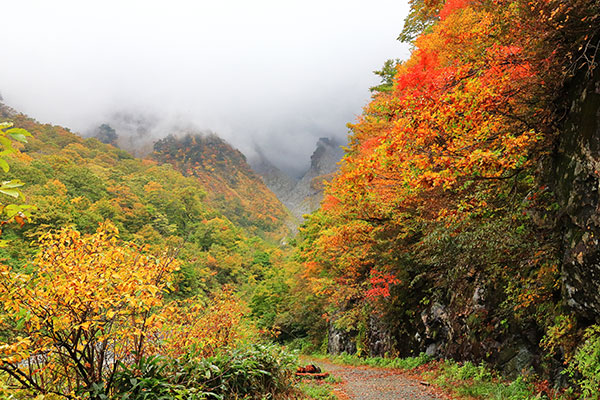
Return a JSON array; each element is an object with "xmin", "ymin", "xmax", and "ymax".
[{"xmin": 114, "ymin": 344, "xmax": 296, "ymax": 400}]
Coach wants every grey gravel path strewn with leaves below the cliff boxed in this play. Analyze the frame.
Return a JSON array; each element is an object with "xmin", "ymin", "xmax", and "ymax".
[{"xmin": 310, "ymin": 360, "xmax": 447, "ymax": 400}]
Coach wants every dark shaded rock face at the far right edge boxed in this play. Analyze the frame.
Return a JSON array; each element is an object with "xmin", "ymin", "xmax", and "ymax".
[{"xmin": 553, "ymin": 68, "xmax": 600, "ymax": 322}]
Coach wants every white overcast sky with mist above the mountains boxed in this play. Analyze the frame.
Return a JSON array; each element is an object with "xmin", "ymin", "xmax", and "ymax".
[{"xmin": 0, "ymin": 0, "xmax": 409, "ymax": 175}]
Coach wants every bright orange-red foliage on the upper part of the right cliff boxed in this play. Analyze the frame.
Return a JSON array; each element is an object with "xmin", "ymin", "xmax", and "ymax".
[{"xmin": 304, "ymin": 0, "xmax": 568, "ymax": 310}]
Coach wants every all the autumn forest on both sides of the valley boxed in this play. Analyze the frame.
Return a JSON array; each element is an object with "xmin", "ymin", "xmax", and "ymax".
[{"xmin": 0, "ymin": 0, "xmax": 600, "ymax": 400}]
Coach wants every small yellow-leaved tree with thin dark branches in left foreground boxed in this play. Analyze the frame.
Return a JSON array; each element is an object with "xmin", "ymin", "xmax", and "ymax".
[{"xmin": 0, "ymin": 222, "xmax": 178, "ymax": 399}]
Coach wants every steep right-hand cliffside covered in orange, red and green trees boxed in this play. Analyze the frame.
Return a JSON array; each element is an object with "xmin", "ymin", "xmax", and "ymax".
[{"xmin": 252, "ymin": 0, "xmax": 600, "ymax": 388}]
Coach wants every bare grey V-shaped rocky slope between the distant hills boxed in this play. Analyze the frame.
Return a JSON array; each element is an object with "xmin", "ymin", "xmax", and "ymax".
[{"xmin": 250, "ymin": 138, "xmax": 344, "ymax": 221}]
